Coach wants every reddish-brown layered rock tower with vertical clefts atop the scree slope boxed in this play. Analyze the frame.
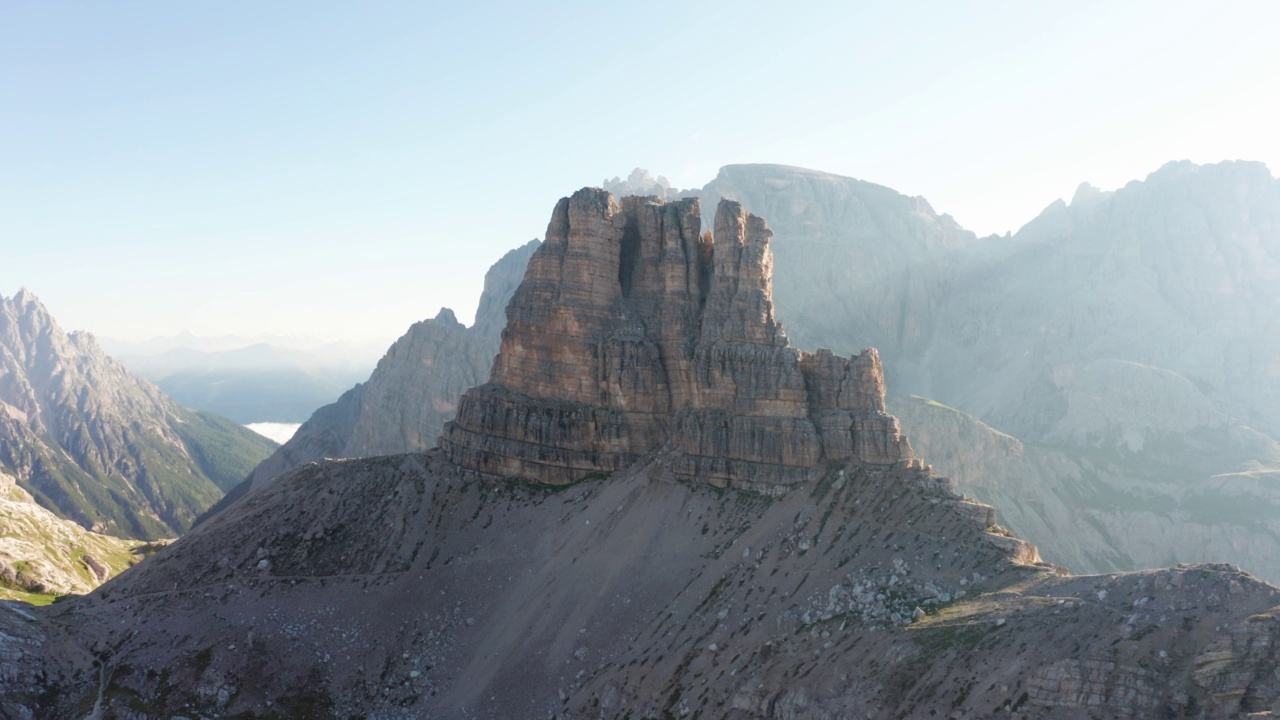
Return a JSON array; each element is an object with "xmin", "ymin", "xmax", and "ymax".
[{"xmin": 440, "ymin": 188, "xmax": 914, "ymax": 491}]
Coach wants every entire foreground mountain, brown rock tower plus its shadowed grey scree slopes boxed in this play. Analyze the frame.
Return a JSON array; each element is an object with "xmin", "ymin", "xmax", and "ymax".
[{"xmin": 0, "ymin": 190, "xmax": 1280, "ymax": 719}]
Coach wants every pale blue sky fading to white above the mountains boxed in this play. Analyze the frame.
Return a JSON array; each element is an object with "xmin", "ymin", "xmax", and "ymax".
[{"xmin": 0, "ymin": 0, "xmax": 1280, "ymax": 341}]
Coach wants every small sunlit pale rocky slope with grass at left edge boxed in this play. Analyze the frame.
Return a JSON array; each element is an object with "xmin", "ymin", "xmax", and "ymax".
[{"xmin": 0, "ymin": 474, "xmax": 155, "ymax": 605}]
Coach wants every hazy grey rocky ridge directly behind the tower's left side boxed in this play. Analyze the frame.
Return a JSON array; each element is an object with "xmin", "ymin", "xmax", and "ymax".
[{"xmin": 241, "ymin": 240, "xmax": 538, "ymax": 492}]
